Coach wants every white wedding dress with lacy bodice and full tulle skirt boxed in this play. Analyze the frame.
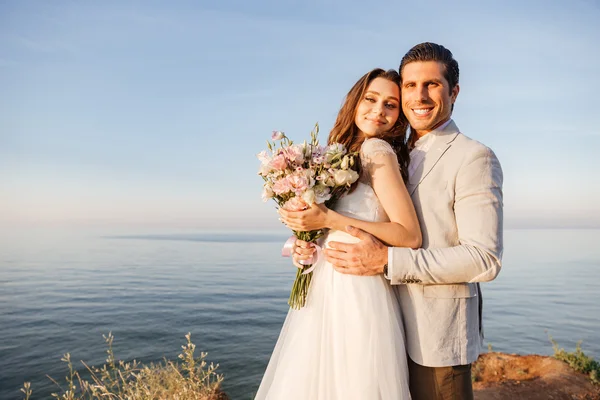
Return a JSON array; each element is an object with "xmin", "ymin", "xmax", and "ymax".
[{"xmin": 255, "ymin": 139, "xmax": 410, "ymax": 400}]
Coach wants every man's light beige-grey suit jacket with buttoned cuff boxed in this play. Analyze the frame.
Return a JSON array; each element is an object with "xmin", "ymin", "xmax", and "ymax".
[{"xmin": 388, "ymin": 121, "xmax": 503, "ymax": 367}]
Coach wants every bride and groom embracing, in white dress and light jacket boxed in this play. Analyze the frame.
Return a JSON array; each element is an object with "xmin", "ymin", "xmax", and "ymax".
[{"xmin": 256, "ymin": 43, "xmax": 502, "ymax": 400}]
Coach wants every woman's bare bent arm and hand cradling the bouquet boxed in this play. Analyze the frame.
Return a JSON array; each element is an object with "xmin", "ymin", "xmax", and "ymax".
[{"xmin": 279, "ymin": 145, "xmax": 421, "ymax": 248}]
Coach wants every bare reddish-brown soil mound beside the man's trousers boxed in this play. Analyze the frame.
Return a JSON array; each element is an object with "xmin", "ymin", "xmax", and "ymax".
[{"xmin": 472, "ymin": 352, "xmax": 600, "ymax": 400}]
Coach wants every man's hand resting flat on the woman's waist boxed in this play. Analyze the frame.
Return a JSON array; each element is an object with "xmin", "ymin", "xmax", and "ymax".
[{"xmin": 324, "ymin": 226, "xmax": 388, "ymax": 276}]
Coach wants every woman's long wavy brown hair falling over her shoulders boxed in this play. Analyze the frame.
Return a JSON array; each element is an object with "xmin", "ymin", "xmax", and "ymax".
[{"xmin": 327, "ymin": 68, "xmax": 410, "ymax": 182}]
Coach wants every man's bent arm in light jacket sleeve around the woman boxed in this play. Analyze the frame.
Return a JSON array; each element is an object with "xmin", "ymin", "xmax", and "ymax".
[{"xmin": 388, "ymin": 148, "xmax": 503, "ymax": 284}]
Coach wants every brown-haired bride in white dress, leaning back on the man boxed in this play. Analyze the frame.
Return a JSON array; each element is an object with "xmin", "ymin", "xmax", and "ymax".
[{"xmin": 256, "ymin": 69, "xmax": 421, "ymax": 400}]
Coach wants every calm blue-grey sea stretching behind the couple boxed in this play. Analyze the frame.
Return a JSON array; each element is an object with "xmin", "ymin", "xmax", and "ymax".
[{"xmin": 0, "ymin": 229, "xmax": 600, "ymax": 400}]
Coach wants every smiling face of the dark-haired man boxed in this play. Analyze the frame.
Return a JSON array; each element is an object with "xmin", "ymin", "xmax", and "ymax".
[{"xmin": 402, "ymin": 61, "xmax": 459, "ymax": 137}]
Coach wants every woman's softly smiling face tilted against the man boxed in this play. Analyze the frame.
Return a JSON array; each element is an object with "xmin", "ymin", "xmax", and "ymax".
[{"xmin": 354, "ymin": 78, "xmax": 400, "ymax": 137}]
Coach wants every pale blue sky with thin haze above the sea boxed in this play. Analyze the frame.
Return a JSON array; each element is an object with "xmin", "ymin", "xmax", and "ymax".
[{"xmin": 0, "ymin": 0, "xmax": 600, "ymax": 231}]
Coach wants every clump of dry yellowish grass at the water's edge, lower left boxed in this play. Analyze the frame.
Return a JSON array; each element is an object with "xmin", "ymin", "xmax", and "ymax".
[{"xmin": 21, "ymin": 333, "xmax": 228, "ymax": 400}]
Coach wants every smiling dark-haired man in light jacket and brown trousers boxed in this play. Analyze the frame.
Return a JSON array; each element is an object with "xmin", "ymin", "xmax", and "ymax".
[{"xmin": 286, "ymin": 43, "xmax": 503, "ymax": 400}]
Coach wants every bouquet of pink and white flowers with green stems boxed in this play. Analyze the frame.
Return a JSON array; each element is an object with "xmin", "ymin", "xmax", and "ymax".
[{"xmin": 257, "ymin": 124, "xmax": 358, "ymax": 309}]
